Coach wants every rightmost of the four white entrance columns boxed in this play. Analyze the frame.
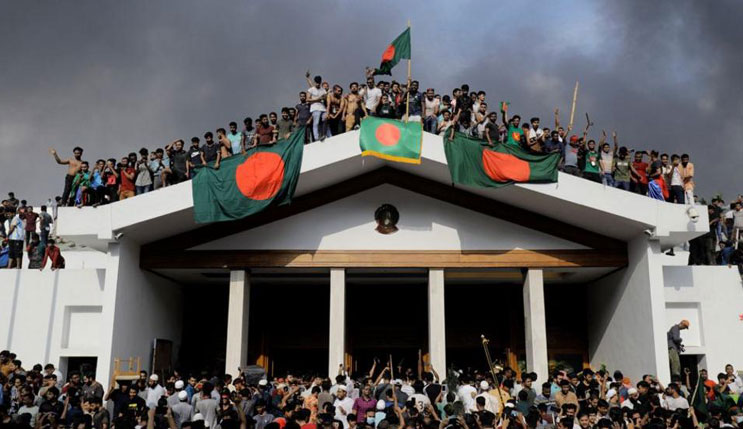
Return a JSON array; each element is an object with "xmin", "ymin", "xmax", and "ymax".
[{"xmin": 524, "ymin": 269, "xmax": 549, "ymax": 380}]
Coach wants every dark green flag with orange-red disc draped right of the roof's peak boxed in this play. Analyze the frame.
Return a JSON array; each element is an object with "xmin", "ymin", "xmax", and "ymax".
[{"xmin": 444, "ymin": 132, "xmax": 560, "ymax": 188}]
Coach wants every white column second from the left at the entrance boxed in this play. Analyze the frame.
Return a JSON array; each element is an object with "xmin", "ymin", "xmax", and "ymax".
[{"xmin": 328, "ymin": 268, "xmax": 346, "ymax": 380}]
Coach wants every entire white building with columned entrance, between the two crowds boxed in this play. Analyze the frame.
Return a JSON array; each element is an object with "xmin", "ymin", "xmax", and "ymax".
[{"xmin": 0, "ymin": 132, "xmax": 743, "ymax": 384}]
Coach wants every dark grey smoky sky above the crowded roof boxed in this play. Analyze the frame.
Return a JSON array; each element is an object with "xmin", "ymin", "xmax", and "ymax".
[{"xmin": 0, "ymin": 0, "xmax": 743, "ymax": 202}]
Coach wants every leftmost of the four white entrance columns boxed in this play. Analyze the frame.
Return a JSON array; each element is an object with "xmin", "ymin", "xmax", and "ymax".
[{"xmin": 224, "ymin": 271, "xmax": 250, "ymax": 377}]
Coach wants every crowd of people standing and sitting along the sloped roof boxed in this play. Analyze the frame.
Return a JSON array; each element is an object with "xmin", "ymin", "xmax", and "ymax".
[{"xmin": 42, "ymin": 70, "xmax": 695, "ymax": 207}]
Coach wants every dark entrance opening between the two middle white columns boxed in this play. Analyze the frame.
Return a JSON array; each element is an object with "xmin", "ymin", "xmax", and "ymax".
[{"xmin": 346, "ymin": 270, "xmax": 428, "ymax": 372}]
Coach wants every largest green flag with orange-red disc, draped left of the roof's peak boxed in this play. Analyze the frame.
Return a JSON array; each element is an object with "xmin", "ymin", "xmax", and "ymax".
[{"xmin": 191, "ymin": 127, "xmax": 305, "ymax": 223}]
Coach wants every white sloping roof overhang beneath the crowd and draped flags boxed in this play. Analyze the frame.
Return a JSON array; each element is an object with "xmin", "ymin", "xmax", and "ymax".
[{"xmin": 57, "ymin": 131, "xmax": 708, "ymax": 250}]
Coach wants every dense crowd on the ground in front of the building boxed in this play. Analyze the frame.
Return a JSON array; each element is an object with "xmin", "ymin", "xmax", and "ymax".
[{"xmin": 0, "ymin": 351, "xmax": 743, "ymax": 429}]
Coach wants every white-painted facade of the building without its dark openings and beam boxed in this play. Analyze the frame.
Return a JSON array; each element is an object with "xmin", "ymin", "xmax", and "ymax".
[{"xmin": 0, "ymin": 132, "xmax": 743, "ymax": 385}]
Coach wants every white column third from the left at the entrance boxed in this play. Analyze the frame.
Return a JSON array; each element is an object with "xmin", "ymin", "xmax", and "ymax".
[{"xmin": 428, "ymin": 268, "xmax": 446, "ymax": 376}]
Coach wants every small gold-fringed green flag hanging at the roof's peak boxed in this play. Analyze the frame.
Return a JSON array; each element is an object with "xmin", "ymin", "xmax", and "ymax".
[{"xmin": 359, "ymin": 116, "xmax": 423, "ymax": 164}]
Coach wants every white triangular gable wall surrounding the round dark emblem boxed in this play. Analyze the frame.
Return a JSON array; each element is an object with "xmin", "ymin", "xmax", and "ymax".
[{"xmin": 195, "ymin": 184, "xmax": 588, "ymax": 251}]
